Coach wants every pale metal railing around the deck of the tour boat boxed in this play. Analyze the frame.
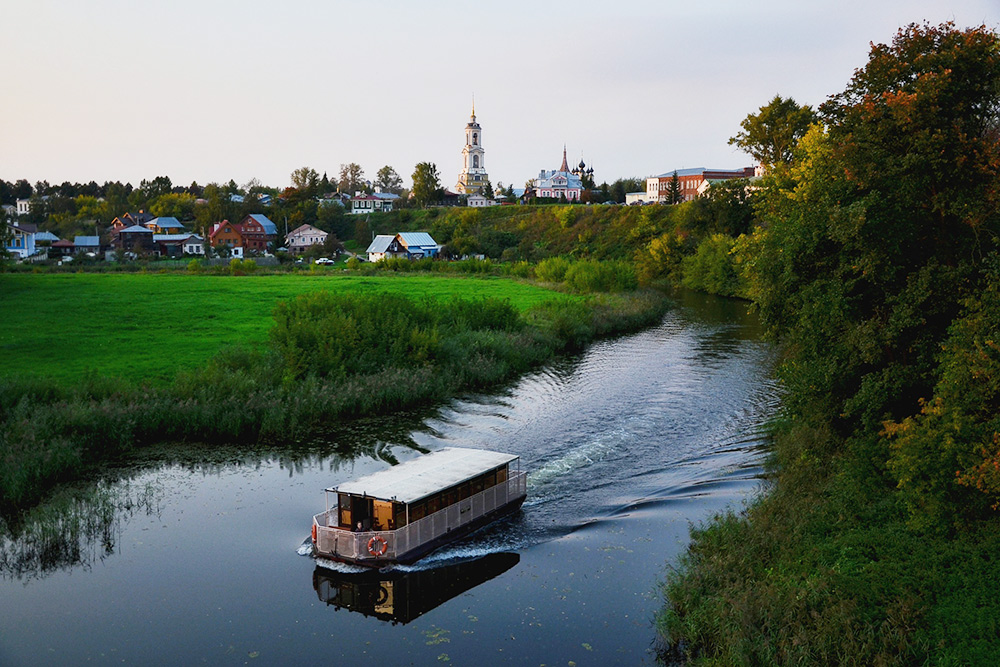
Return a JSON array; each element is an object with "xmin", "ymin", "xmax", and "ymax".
[{"xmin": 313, "ymin": 472, "xmax": 527, "ymax": 560}]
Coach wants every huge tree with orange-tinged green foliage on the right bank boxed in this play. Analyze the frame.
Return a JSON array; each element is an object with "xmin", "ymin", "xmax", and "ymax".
[{"xmin": 737, "ymin": 23, "xmax": 1000, "ymax": 526}]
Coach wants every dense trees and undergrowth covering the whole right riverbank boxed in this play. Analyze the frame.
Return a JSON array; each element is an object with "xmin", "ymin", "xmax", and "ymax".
[{"xmin": 657, "ymin": 24, "xmax": 1000, "ymax": 665}]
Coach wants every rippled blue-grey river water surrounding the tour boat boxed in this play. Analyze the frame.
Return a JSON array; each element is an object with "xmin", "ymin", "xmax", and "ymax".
[{"xmin": 0, "ymin": 293, "xmax": 779, "ymax": 665}]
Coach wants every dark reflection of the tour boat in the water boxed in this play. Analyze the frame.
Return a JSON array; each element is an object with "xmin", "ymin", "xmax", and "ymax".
[{"xmin": 313, "ymin": 553, "xmax": 521, "ymax": 623}]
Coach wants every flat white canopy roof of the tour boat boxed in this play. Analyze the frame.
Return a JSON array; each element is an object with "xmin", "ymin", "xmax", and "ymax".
[{"xmin": 327, "ymin": 447, "xmax": 518, "ymax": 503}]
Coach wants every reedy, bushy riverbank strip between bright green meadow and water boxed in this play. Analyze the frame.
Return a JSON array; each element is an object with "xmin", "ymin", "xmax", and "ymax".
[{"xmin": 0, "ymin": 276, "xmax": 667, "ymax": 511}]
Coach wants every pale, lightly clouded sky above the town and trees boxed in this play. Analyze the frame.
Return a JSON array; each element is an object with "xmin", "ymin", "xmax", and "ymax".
[{"xmin": 0, "ymin": 0, "xmax": 1000, "ymax": 192}]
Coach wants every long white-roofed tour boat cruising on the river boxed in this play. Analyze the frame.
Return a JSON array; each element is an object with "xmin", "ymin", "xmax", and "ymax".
[{"xmin": 312, "ymin": 447, "xmax": 527, "ymax": 567}]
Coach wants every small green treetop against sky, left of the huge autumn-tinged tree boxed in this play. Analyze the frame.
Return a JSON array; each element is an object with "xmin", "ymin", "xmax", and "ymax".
[{"xmin": 729, "ymin": 95, "xmax": 816, "ymax": 168}]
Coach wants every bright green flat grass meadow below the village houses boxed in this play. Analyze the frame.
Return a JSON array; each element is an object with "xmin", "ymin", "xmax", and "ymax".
[{"xmin": 0, "ymin": 273, "xmax": 573, "ymax": 384}]
